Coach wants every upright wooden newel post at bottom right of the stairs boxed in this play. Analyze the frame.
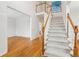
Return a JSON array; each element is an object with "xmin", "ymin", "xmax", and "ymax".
[{"xmin": 73, "ymin": 26, "xmax": 78, "ymax": 57}]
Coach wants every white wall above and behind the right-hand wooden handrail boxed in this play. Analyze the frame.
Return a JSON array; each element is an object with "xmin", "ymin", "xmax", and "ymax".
[{"xmin": 68, "ymin": 1, "xmax": 79, "ymax": 38}]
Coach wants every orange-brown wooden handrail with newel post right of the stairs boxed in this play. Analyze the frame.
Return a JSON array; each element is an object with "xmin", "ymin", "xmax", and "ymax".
[{"xmin": 67, "ymin": 14, "xmax": 79, "ymax": 57}]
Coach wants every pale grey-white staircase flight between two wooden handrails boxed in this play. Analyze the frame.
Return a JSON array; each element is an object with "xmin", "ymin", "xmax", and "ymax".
[{"xmin": 44, "ymin": 13, "xmax": 71, "ymax": 57}]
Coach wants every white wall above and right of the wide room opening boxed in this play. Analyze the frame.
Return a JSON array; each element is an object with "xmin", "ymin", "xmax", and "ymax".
[{"xmin": 7, "ymin": 1, "xmax": 39, "ymax": 38}]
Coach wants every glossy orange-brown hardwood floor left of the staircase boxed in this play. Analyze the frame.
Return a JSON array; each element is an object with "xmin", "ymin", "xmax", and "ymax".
[{"xmin": 3, "ymin": 37, "xmax": 42, "ymax": 57}]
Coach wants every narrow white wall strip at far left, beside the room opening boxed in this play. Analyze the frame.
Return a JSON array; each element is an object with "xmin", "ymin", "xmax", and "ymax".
[{"xmin": 0, "ymin": 2, "xmax": 7, "ymax": 56}]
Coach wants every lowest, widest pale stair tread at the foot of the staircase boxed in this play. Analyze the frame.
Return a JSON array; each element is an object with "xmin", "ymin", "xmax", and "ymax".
[{"xmin": 45, "ymin": 47, "xmax": 70, "ymax": 57}]
